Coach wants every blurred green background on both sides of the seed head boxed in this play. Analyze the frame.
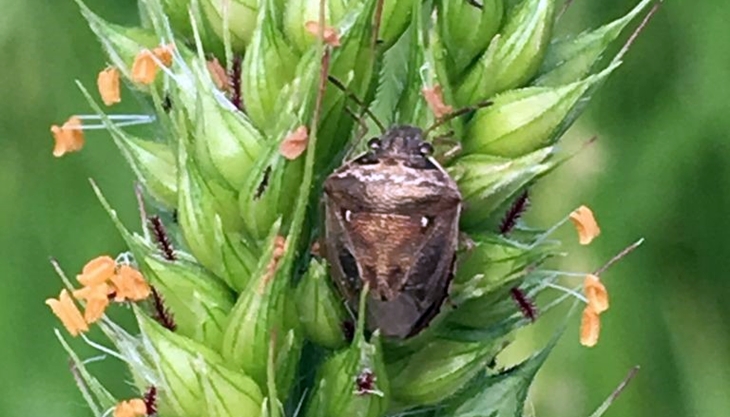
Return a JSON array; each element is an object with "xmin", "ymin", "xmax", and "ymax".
[{"xmin": 0, "ymin": 0, "xmax": 730, "ymax": 417}]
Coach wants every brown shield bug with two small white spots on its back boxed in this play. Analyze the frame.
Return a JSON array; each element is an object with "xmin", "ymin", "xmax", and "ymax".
[{"xmin": 323, "ymin": 126, "xmax": 461, "ymax": 338}]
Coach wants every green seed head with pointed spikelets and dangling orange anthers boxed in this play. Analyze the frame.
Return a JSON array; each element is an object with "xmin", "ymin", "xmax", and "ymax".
[{"xmin": 49, "ymin": 0, "xmax": 650, "ymax": 417}]
